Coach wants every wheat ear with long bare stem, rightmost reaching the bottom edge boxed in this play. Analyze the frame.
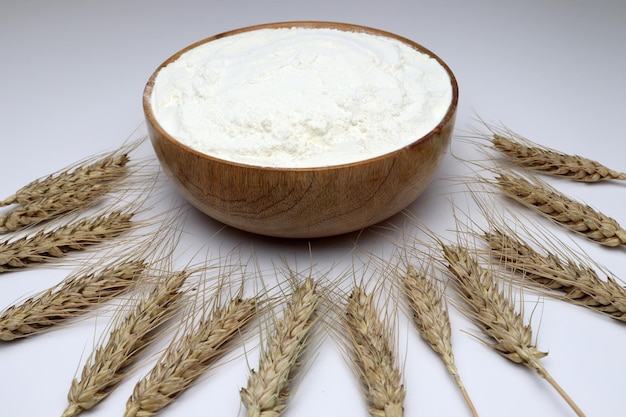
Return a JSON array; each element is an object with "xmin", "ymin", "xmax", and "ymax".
[{"xmin": 442, "ymin": 244, "xmax": 585, "ymax": 417}]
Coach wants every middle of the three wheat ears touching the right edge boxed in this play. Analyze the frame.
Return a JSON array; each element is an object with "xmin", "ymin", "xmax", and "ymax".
[{"xmin": 495, "ymin": 173, "xmax": 626, "ymax": 247}]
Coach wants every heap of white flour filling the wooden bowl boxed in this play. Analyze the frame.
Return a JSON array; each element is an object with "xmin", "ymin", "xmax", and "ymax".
[{"xmin": 152, "ymin": 28, "xmax": 452, "ymax": 168}]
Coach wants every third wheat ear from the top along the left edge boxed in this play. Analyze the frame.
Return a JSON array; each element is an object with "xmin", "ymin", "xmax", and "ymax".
[{"xmin": 0, "ymin": 210, "xmax": 134, "ymax": 273}]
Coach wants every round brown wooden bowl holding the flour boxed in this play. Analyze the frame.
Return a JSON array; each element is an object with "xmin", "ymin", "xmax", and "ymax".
[{"xmin": 143, "ymin": 22, "xmax": 458, "ymax": 238}]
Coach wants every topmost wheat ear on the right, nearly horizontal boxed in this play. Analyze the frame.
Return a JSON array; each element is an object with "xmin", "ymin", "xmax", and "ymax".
[{"xmin": 491, "ymin": 132, "xmax": 626, "ymax": 182}]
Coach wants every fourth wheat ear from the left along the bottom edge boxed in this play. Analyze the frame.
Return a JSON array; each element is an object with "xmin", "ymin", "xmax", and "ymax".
[{"xmin": 345, "ymin": 287, "xmax": 406, "ymax": 417}]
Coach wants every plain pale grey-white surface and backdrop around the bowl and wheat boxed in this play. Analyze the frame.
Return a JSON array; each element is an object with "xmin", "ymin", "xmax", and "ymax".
[{"xmin": 0, "ymin": 0, "xmax": 626, "ymax": 417}]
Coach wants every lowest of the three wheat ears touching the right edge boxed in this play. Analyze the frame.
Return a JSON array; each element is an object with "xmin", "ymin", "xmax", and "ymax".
[{"xmin": 484, "ymin": 229, "xmax": 626, "ymax": 321}]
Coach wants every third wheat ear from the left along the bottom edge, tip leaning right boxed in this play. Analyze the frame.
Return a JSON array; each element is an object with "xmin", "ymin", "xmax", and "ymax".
[{"xmin": 240, "ymin": 278, "xmax": 320, "ymax": 417}]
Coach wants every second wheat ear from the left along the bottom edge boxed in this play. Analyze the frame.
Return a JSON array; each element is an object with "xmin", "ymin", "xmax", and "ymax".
[{"xmin": 124, "ymin": 296, "xmax": 258, "ymax": 417}]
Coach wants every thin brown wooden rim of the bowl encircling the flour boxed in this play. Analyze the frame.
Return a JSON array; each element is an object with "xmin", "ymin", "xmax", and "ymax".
[{"xmin": 142, "ymin": 20, "xmax": 459, "ymax": 172}]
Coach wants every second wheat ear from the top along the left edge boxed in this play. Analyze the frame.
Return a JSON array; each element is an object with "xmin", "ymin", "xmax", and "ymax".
[{"xmin": 0, "ymin": 183, "xmax": 111, "ymax": 234}]
